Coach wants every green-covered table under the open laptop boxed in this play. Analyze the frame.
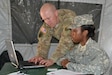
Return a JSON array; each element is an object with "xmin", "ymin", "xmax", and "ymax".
[{"xmin": 0, "ymin": 62, "xmax": 62, "ymax": 75}]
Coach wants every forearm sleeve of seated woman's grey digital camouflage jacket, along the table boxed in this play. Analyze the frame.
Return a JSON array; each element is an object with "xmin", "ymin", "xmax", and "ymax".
[{"xmin": 66, "ymin": 54, "xmax": 109, "ymax": 75}]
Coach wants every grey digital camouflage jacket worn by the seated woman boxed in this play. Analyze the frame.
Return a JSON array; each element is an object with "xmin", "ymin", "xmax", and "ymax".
[{"xmin": 57, "ymin": 38, "xmax": 110, "ymax": 75}]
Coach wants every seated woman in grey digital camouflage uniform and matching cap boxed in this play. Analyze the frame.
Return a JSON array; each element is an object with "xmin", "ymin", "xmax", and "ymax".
[{"xmin": 57, "ymin": 14, "xmax": 110, "ymax": 75}]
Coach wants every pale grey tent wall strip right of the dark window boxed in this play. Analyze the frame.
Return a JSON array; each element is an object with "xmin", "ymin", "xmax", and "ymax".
[{"xmin": 99, "ymin": 0, "xmax": 112, "ymax": 61}]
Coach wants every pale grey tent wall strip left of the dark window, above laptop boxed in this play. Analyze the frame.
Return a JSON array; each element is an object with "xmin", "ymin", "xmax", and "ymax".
[{"xmin": 0, "ymin": 0, "xmax": 11, "ymax": 54}]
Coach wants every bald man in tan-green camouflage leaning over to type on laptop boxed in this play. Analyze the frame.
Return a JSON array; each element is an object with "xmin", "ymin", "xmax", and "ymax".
[{"xmin": 29, "ymin": 3, "xmax": 76, "ymax": 66}]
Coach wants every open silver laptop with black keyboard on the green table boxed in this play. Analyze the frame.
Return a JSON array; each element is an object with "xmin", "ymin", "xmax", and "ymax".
[{"xmin": 5, "ymin": 40, "xmax": 45, "ymax": 69}]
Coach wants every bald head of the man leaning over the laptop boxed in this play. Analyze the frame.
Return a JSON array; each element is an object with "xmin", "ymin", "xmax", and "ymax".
[{"xmin": 40, "ymin": 3, "xmax": 58, "ymax": 27}]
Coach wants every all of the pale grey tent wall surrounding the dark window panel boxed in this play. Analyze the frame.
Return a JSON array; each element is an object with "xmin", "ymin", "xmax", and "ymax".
[{"xmin": 0, "ymin": 0, "xmax": 112, "ymax": 64}]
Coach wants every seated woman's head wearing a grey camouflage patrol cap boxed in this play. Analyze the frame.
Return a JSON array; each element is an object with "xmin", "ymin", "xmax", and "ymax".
[{"xmin": 69, "ymin": 14, "xmax": 95, "ymax": 43}]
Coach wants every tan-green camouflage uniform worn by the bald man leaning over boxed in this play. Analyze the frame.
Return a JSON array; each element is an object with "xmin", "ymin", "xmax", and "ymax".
[{"xmin": 37, "ymin": 9, "xmax": 76, "ymax": 62}]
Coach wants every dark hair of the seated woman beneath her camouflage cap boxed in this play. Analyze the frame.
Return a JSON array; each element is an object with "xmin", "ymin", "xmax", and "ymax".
[{"xmin": 81, "ymin": 25, "xmax": 95, "ymax": 38}]
